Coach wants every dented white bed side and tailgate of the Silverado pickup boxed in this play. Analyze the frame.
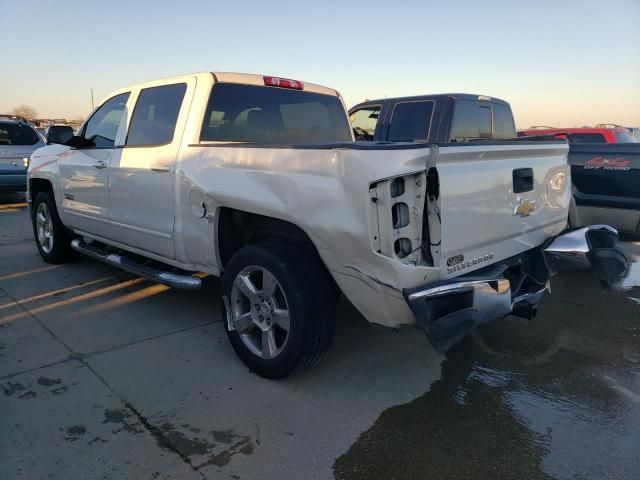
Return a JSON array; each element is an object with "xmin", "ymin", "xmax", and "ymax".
[{"xmin": 174, "ymin": 144, "xmax": 569, "ymax": 326}]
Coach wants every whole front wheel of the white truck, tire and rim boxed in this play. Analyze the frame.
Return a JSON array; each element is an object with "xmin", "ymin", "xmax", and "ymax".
[{"xmin": 31, "ymin": 192, "xmax": 73, "ymax": 263}]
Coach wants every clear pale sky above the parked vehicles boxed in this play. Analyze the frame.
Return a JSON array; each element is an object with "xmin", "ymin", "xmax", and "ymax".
[{"xmin": 0, "ymin": 0, "xmax": 640, "ymax": 127}]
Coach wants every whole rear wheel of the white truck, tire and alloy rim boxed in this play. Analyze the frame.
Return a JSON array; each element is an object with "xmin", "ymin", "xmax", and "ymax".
[{"xmin": 222, "ymin": 242, "xmax": 336, "ymax": 378}]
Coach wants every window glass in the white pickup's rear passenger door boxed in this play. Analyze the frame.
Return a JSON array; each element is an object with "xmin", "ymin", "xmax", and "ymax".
[{"xmin": 126, "ymin": 83, "xmax": 187, "ymax": 146}]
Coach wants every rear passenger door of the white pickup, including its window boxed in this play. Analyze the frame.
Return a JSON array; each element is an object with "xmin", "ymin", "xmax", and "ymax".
[{"xmin": 109, "ymin": 78, "xmax": 195, "ymax": 259}]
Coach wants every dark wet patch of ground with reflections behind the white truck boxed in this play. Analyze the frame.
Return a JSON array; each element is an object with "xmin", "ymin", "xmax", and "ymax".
[{"xmin": 334, "ymin": 264, "xmax": 640, "ymax": 479}]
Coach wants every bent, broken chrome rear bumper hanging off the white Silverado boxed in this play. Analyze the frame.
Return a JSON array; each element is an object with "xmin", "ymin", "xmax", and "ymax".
[{"xmin": 403, "ymin": 225, "xmax": 629, "ymax": 353}]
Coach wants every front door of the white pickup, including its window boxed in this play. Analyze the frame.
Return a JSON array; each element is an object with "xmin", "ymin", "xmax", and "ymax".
[{"xmin": 59, "ymin": 92, "xmax": 129, "ymax": 238}]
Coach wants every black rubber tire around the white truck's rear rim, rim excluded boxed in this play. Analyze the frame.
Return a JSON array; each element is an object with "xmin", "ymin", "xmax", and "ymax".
[{"xmin": 222, "ymin": 241, "xmax": 336, "ymax": 379}]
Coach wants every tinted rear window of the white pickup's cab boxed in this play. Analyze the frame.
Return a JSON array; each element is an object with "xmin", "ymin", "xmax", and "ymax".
[{"xmin": 200, "ymin": 83, "xmax": 352, "ymax": 144}]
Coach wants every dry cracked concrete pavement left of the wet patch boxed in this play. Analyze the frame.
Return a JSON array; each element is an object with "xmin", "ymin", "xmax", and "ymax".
[{"xmin": 0, "ymin": 193, "xmax": 441, "ymax": 479}]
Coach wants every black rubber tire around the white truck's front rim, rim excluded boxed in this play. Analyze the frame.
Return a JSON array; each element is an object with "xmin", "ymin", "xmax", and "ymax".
[{"xmin": 31, "ymin": 191, "xmax": 73, "ymax": 263}]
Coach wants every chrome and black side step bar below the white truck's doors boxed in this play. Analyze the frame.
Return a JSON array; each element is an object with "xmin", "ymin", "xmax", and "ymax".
[{"xmin": 71, "ymin": 238, "xmax": 202, "ymax": 290}]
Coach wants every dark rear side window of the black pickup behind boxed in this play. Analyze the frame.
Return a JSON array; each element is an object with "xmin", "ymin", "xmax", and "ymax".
[{"xmin": 387, "ymin": 100, "xmax": 435, "ymax": 142}]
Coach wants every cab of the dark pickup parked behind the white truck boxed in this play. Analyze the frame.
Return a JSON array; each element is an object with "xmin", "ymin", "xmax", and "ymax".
[{"xmin": 349, "ymin": 93, "xmax": 516, "ymax": 143}]
